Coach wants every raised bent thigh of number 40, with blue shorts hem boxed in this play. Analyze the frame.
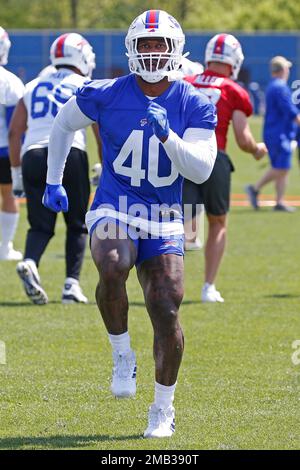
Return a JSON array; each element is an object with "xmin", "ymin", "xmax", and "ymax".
[{"xmin": 90, "ymin": 219, "xmax": 137, "ymax": 279}]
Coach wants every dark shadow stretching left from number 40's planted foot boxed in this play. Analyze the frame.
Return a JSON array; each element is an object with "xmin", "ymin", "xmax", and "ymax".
[{"xmin": 0, "ymin": 434, "xmax": 143, "ymax": 450}]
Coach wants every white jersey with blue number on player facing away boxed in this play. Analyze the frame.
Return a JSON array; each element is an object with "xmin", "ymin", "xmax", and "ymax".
[{"xmin": 21, "ymin": 68, "xmax": 89, "ymax": 155}]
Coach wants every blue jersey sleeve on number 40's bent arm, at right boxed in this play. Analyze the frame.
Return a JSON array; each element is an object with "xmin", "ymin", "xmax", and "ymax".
[{"xmin": 187, "ymin": 91, "xmax": 217, "ymax": 130}]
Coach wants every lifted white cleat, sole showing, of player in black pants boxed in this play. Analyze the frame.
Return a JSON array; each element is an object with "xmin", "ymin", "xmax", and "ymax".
[{"xmin": 17, "ymin": 261, "xmax": 48, "ymax": 305}]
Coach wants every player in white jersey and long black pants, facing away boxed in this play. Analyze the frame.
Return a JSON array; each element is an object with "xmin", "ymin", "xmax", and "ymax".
[{"xmin": 9, "ymin": 33, "xmax": 95, "ymax": 305}]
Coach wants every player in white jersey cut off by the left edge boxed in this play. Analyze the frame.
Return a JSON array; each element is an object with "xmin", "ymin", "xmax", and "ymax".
[{"xmin": 0, "ymin": 27, "xmax": 24, "ymax": 261}]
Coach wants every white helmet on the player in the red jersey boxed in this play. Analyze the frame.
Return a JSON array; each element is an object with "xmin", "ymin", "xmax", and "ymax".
[{"xmin": 205, "ymin": 34, "xmax": 244, "ymax": 80}]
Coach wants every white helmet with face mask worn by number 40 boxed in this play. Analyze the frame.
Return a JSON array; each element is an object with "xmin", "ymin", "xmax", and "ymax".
[{"xmin": 125, "ymin": 10, "xmax": 185, "ymax": 83}]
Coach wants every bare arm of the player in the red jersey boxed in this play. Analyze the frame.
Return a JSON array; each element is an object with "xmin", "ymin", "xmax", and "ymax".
[{"xmin": 232, "ymin": 110, "xmax": 267, "ymax": 160}]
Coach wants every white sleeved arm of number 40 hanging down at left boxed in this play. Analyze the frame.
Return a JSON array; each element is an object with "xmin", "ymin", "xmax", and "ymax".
[{"xmin": 47, "ymin": 96, "xmax": 94, "ymax": 185}]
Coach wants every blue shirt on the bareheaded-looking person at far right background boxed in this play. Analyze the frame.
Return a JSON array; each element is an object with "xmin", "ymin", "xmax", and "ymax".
[{"xmin": 264, "ymin": 78, "xmax": 299, "ymax": 145}]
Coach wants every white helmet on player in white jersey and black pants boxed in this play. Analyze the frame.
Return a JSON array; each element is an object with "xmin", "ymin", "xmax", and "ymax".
[{"xmin": 50, "ymin": 33, "xmax": 96, "ymax": 76}]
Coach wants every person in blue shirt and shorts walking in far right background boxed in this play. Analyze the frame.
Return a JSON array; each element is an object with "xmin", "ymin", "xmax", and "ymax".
[{"xmin": 246, "ymin": 56, "xmax": 300, "ymax": 212}]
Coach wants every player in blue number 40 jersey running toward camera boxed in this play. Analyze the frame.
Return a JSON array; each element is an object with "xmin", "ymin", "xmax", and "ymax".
[{"xmin": 44, "ymin": 10, "xmax": 217, "ymax": 437}]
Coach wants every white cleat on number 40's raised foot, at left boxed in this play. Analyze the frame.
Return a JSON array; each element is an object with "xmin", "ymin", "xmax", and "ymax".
[{"xmin": 110, "ymin": 350, "xmax": 136, "ymax": 398}]
